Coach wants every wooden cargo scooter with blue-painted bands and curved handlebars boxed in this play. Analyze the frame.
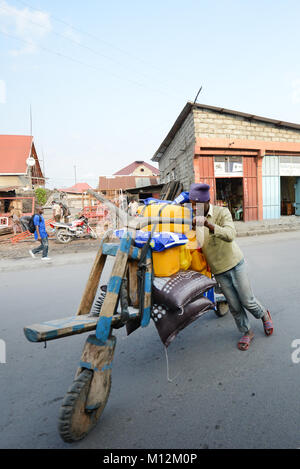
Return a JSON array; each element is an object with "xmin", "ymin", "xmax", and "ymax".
[{"xmin": 24, "ymin": 190, "xmax": 191, "ymax": 443}]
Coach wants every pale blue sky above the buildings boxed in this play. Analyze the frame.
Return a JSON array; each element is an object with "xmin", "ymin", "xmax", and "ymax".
[{"xmin": 0, "ymin": 0, "xmax": 300, "ymax": 187}]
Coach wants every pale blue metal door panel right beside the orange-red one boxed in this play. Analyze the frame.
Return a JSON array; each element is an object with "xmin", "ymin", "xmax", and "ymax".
[{"xmin": 262, "ymin": 155, "xmax": 281, "ymax": 220}]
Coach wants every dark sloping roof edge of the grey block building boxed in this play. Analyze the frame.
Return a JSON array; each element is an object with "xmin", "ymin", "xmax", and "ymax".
[{"xmin": 151, "ymin": 102, "xmax": 300, "ymax": 161}]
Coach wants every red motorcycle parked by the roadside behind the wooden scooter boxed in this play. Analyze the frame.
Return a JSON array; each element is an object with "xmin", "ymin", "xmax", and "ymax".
[{"xmin": 50, "ymin": 217, "xmax": 97, "ymax": 244}]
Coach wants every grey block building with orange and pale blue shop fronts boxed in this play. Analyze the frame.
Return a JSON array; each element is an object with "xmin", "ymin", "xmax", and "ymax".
[{"xmin": 152, "ymin": 102, "xmax": 300, "ymax": 221}]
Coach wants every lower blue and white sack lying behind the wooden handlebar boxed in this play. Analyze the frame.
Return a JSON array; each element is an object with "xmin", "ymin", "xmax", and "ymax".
[{"xmin": 114, "ymin": 230, "xmax": 188, "ymax": 252}]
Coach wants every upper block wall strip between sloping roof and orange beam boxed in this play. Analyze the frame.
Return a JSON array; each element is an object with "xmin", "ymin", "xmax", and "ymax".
[{"xmin": 192, "ymin": 109, "xmax": 300, "ymax": 142}]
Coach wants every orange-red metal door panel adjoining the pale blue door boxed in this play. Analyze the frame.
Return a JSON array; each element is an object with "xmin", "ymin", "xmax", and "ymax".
[{"xmin": 243, "ymin": 157, "xmax": 258, "ymax": 221}]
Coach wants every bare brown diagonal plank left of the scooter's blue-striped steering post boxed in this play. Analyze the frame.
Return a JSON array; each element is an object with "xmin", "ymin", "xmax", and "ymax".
[{"xmin": 77, "ymin": 232, "xmax": 111, "ymax": 316}]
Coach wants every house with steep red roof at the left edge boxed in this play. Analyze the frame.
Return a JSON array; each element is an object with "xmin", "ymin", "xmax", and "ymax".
[{"xmin": 0, "ymin": 135, "xmax": 45, "ymax": 192}]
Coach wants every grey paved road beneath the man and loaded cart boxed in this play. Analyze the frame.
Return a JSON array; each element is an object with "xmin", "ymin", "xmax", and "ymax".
[{"xmin": 0, "ymin": 232, "xmax": 300, "ymax": 449}]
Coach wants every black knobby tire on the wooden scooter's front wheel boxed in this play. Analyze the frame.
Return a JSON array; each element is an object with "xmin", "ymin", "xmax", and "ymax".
[{"xmin": 58, "ymin": 369, "xmax": 111, "ymax": 443}]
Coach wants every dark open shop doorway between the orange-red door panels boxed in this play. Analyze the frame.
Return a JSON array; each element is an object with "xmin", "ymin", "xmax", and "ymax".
[{"xmin": 216, "ymin": 177, "xmax": 244, "ymax": 221}]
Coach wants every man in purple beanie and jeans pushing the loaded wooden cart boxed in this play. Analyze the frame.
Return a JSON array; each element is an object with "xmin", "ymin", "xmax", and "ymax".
[{"xmin": 189, "ymin": 184, "xmax": 273, "ymax": 350}]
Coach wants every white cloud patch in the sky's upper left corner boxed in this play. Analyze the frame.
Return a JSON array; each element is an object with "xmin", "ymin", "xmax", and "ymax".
[{"xmin": 0, "ymin": 0, "xmax": 52, "ymax": 55}]
